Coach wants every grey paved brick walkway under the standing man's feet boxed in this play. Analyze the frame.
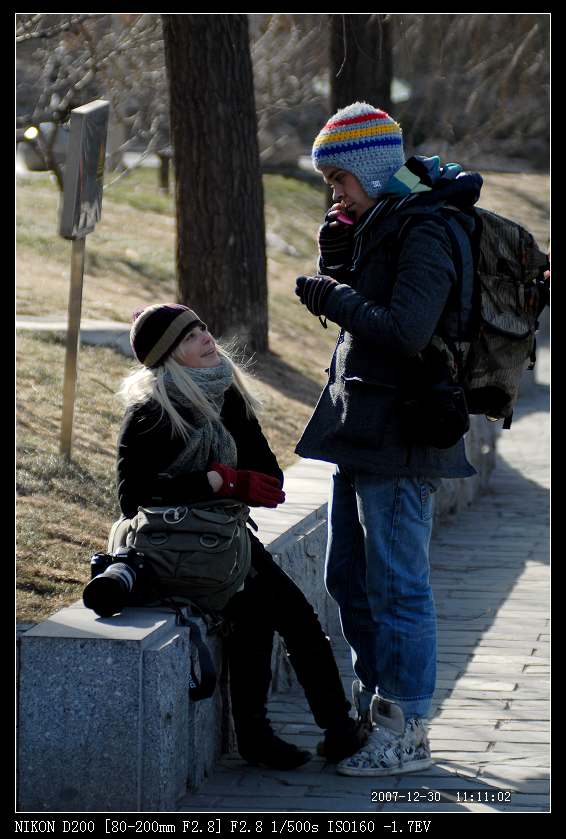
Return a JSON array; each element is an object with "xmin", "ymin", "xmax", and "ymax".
[{"xmin": 179, "ymin": 355, "xmax": 550, "ymax": 813}]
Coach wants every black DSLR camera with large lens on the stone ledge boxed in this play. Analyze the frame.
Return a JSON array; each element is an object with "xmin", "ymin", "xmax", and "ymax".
[{"xmin": 83, "ymin": 546, "xmax": 149, "ymax": 618}]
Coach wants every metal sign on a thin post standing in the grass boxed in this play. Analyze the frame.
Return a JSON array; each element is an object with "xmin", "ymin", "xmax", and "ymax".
[{"xmin": 59, "ymin": 99, "xmax": 110, "ymax": 460}]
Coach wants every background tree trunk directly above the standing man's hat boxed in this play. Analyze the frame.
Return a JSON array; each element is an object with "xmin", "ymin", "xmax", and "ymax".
[{"xmin": 330, "ymin": 14, "xmax": 393, "ymax": 113}]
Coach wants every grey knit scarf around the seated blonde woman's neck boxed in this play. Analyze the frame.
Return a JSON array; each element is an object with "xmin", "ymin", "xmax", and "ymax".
[{"xmin": 164, "ymin": 356, "xmax": 238, "ymax": 476}]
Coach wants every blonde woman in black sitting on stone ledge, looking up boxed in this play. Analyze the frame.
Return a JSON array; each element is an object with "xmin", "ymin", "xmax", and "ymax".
[{"xmin": 117, "ymin": 304, "xmax": 369, "ymax": 769}]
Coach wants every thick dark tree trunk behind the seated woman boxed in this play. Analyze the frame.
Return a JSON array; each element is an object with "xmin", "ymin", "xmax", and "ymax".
[{"xmin": 162, "ymin": 14, "xmax": 268, "ymax": 352}]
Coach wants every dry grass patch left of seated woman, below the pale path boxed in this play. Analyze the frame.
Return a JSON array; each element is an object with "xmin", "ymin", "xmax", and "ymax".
[{"xmin": 16, "ymin": 333, "xmax": 129, "ymax": 621}]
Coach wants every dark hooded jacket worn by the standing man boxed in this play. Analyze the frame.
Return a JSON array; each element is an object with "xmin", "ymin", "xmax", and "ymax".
[{"xmin": 295, "ymin": 175, "xmax": 481, "ymax": 478}]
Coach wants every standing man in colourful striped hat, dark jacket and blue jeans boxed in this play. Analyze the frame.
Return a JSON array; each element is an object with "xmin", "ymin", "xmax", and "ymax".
[{"xmin": 296, "ymin": 102, "xmax": 482, "ymax": 776}]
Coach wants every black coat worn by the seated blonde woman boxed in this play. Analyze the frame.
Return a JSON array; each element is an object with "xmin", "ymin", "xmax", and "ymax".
[{"xmin": 116, "ymin": 386, "xmax": 283, "ymax": 518}]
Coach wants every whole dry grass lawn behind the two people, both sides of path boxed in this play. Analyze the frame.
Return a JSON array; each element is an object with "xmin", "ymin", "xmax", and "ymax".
[{"xmin": 17, "ymin": 171, "xmax": 548, "ymax": 621}]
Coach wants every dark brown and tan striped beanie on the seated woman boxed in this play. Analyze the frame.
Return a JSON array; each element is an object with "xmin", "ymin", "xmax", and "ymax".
[{"xmin": 130, "ymin": 303, "xmax": 206, "ymax": 367}]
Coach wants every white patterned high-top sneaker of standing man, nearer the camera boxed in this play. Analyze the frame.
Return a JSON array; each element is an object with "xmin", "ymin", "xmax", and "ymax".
[{"xmin": 336, "ymin": 697, "xmax": 432, "ymax": 777}]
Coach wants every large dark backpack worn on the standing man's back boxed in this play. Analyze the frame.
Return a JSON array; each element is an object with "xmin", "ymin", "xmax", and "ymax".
[{"xmin": 399, "ymin": 207, "xmax": 548, "ymax": 428}]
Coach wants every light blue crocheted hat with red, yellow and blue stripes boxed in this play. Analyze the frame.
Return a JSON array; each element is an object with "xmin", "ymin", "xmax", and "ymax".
[{"xmin": 312, "ymin": 102, "xmax": 405, "ymax": 198}]
